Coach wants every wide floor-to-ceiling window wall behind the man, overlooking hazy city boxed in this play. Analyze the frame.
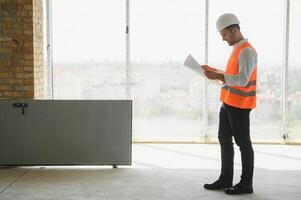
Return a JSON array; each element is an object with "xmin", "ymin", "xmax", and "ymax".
[{"xmin": 48, "ymin": 0, "xmax": 301, "ymax": 142}]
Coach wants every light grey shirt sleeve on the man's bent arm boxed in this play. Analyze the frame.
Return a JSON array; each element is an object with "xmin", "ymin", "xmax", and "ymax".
[{"xmin": 224, "ymin": 47, "xmax": 257, "ymax": 86}]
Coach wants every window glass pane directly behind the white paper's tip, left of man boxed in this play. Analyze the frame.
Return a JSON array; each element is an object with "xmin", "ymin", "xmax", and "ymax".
[{"xmin": 130, "ymin": 0, "xmax": 205, "ymax": 141}]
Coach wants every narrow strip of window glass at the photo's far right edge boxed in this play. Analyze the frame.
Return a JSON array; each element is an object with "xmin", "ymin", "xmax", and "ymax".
[{"xmin": 287, "ymin": 0, "xmax": 301, "ymax": 142}]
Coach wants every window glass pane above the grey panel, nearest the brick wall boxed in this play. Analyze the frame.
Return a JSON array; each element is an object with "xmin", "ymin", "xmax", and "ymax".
[{"xmin": 52, "ymin": 0, "xmax": 126, "ymax": 99}]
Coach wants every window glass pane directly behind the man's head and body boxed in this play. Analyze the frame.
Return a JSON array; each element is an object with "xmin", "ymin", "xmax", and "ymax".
[{"xmin": 208, "ymin": 0, "xmax": 284, "ymax": 141}]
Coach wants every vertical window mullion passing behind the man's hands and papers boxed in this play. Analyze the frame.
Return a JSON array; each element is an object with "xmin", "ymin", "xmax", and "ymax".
[{"xmin": 203, "ymin": 0, "xmax": 209, "ymax": 143}]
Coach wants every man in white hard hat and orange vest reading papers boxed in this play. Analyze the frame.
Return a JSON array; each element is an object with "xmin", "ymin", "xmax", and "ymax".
[{"xmin": 202, "ymin": 13, "xmax": 257, "ymax": 194}]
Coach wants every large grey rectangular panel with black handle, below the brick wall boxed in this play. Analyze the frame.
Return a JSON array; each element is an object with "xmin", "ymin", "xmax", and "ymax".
[{"xmin": 0, "ymin": 100, "xmax": 132, "ymax": 165}]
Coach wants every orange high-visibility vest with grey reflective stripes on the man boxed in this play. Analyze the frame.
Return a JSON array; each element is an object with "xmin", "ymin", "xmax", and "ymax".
[{"xmin": 220, "ymin": 42, "xmax": 257, "ymax": 109}]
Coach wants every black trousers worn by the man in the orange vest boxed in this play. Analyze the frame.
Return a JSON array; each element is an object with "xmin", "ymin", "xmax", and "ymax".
[{"xmin": 218, "ymin": 103, "xmax": 254, "ymax": 185}]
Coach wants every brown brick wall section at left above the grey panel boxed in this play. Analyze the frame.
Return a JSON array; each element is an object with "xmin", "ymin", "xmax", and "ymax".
[{"xmin": 0, "ymin": 0, "xmax": 44, "ymax": 99}]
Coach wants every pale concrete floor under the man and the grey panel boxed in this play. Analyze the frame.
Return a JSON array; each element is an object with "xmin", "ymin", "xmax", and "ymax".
[{"xmin": 0, "ymin": 144, "xmax": 301, "ymax": 200}]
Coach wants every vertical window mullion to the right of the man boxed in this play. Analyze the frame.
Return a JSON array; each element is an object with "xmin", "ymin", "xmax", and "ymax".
[{"xmin": 281, "ymin": 0, "xmax": 290, "ymax": 143}]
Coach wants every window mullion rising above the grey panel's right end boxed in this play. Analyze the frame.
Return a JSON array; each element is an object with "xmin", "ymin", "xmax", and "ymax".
[{"xmin": 125, "ymin": 0, "xmax": 131, "ymax": 99}]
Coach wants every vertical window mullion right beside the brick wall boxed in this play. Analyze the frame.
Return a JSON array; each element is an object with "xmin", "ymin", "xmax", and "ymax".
[{"xmin": 46, "ymin": 0, "xmax": 53, "ymax": 99}]
